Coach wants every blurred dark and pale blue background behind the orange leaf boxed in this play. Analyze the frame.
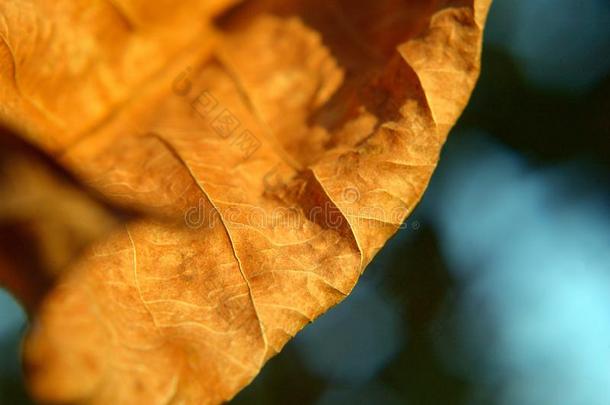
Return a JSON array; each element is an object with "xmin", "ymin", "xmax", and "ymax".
[{"xmin": 0, "ymin": 0, "xmax": 610, "ymax": 405}]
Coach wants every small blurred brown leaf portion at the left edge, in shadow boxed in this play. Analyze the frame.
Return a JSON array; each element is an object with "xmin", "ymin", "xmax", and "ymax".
[{"xmin": 0, "ymin": 127, "xmax": 134, "ymax": 312}]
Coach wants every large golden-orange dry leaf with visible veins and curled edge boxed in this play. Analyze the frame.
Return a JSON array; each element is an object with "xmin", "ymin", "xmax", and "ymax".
[{"xmin": 0, "ymin": 0, "xmax": 489, "ymax": 404}]
